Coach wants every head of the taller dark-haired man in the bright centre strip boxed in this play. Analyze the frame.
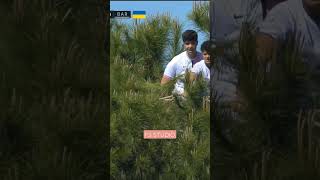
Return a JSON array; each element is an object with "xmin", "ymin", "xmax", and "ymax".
[{"xmin": 182, "ymin": 30, "xmax": 198, "ymax": 58}]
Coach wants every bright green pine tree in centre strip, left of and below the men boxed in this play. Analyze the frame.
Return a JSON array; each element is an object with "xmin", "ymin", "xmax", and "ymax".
[{"xmin": 110, "ymin": 4, "xmax": 210, "ymax": 179}]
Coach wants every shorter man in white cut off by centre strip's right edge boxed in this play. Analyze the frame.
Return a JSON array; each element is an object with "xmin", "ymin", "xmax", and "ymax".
[{"xmin": 191, "ymin": 41, "xmax": 213, "ymax": 93}]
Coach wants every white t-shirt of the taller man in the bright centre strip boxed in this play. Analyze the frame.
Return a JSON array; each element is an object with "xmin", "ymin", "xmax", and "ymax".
[{"xmin": 164, "ymin": 51, "xmax": 203, "ymax": 94}]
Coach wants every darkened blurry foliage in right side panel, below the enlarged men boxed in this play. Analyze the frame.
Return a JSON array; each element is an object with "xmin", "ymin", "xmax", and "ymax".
[{"xmin": 211, "ymin": 17, "xmax": 319, "ymax": 180}]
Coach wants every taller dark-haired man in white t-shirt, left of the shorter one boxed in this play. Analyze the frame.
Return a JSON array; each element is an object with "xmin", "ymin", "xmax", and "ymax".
[{"xmin": 161, "ymin": 30, "xmax": 203, "ymax": 95}]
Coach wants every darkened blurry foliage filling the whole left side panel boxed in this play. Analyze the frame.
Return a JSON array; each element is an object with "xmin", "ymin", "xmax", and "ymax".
[{"xmin": 0, "ymin": 0, "xmax": 108, "ymax": 180}]
